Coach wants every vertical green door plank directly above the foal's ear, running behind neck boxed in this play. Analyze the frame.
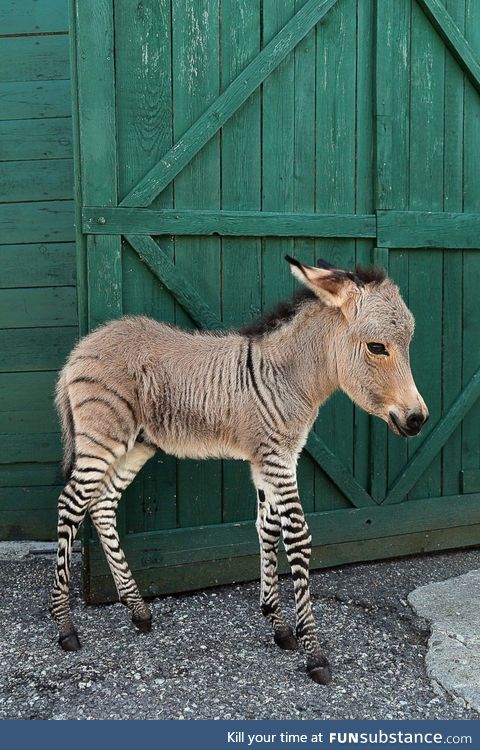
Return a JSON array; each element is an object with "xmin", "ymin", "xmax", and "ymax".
[{"xmin": 314, "ymin": 0, "xmax": 357, "ymax": 510}]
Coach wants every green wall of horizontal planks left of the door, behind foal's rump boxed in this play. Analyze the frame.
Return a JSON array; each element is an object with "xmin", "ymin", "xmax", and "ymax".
[{"xmin": 0, "ymin": 0, "xmax": 78, "ymax": 539}]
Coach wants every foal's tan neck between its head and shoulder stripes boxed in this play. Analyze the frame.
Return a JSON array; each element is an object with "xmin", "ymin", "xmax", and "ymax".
[{"xmin": 260, "ymin": 300, "xmax": 344, "ymax": 409}]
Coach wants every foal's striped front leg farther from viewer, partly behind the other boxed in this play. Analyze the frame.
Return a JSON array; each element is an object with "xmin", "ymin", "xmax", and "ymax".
[{"xmin": 257, "ymin": 489, "xmax": 298, "ymax": 651}]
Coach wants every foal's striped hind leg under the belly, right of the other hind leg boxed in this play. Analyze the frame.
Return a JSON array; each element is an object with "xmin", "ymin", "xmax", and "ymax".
[{"xmin": 89, "ymin": 443, "xmax": 155, "ymax": 632}]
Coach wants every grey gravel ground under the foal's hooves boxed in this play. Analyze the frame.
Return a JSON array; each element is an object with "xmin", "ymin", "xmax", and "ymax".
[{"xmin": 0, "ymin": 549, "xmax": 480, "ymax": 719}]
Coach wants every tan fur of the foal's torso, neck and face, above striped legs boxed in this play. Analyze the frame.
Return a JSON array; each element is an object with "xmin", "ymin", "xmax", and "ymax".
[{"xmin": 57, "ymin": 274, "xmax": 426, "ymax": 476}]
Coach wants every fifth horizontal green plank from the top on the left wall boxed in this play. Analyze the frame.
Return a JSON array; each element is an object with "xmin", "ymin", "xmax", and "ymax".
[{"xmin": 0, "ymin": 159, "xmax": 73, "ymax": 203}]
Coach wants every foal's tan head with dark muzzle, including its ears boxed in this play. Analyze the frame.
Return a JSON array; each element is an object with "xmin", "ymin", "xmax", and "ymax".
[{"xmin": 286, "ymin": 256, "xmax": 428, "ymax": 437}]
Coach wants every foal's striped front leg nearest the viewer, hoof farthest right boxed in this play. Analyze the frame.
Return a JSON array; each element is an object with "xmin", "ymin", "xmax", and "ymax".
[{"xmin": 255, "ymin": 459, "xmax": 331, "ymax": 684}]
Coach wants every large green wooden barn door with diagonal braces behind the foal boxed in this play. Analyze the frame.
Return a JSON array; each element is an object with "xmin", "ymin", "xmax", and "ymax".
[{"xmin": 72, "ymin": 0, "xmax": 480, "ymax": 601}]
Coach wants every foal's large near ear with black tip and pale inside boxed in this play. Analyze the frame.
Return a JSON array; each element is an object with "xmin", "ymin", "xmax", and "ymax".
[{"xmin": 285, "ymin": 255, "xmax": 358, "ymax": 307}]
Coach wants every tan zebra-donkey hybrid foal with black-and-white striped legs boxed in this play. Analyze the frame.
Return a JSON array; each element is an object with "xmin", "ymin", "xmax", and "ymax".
[{"xmin": 51, "ymin": 256, "xmax": 428, "ymax": 684}]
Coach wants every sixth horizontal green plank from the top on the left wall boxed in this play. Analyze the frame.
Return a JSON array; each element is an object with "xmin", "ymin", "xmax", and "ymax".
[{"xmin": 0, "ymin": 200, "xmax": 74, "ymax": 245}]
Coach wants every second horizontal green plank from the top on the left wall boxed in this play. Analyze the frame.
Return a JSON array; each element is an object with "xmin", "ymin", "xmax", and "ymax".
[{"xmin": 0, "ymin": 34, "xmax": 70, "ymax": 81}]
